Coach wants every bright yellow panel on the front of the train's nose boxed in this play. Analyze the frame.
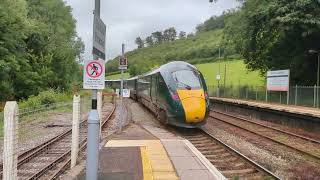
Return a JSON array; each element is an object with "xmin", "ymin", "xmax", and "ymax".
[{"xmin": 177, "ymin": 89, "xmax": 206, "ymax": 123}]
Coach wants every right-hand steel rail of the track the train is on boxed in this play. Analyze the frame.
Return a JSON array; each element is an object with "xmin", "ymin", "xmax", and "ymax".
[{"xmin": 199, "ymin": 128, "xmax": 281, "ymax": 180}]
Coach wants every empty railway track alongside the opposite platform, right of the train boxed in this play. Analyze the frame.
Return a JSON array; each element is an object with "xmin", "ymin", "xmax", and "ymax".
[{"xmin": 210, "ymin": 111, "xmax": 320, "ymax": 160}]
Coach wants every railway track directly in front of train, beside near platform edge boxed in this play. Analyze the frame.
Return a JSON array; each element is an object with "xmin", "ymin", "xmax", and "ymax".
[{"xmin": 182, "ymin": 129, "xmax": 280, "ymax": 179}]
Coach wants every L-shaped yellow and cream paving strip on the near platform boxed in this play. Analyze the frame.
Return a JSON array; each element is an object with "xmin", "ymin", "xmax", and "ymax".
[{"xmin": 105, "ymin": 140, "xmax": 179, "ymax": 180}]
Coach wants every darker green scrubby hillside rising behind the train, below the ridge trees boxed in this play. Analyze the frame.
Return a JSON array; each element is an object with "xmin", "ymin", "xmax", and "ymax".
[{"xmin": 106, "ymin": 30, "xmax": 239, "ymax": 75}]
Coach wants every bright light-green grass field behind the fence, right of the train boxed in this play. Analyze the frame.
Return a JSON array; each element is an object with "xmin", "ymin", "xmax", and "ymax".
[{"xmin": 196, "ymin": 60, "xmax": 265, "ymax": 86}]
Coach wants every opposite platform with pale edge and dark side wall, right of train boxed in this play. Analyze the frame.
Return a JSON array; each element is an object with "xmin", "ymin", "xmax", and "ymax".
[{"xmin": 210, "ymin": 97, "xmax": 320, "ymax": 133}]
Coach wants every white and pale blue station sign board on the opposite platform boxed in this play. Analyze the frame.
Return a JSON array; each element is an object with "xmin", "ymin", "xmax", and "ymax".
[{"xmin": 267, "ymin": 69, "xmax": 290, "ymax": 91}]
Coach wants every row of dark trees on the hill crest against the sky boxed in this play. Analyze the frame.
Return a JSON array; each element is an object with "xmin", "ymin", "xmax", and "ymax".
[{"xmin": 135, "ymin": 27, "xmax": 193, "ymax": 48}]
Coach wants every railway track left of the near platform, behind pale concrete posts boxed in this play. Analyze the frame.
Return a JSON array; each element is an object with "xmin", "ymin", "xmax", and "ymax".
[{"xmin": 1, "ymin": 100, "xmax": 116, "ymax": 180}]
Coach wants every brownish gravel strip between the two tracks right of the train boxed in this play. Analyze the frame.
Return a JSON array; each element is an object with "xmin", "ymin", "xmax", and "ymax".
[{"xmin": 205, "ymin": 118, "xmax": 319, "ymax": 179}]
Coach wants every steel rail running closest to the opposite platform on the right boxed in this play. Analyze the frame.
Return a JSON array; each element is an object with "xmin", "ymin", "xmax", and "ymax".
[{"xmin": 211, "ymin": 110, "xmax": 320, "ymax": 144}]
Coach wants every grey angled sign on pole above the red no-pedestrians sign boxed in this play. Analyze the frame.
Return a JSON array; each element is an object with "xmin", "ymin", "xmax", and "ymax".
[{"xmin": 92, "ymin": 15, "xmax": 106, "ymax": 60}]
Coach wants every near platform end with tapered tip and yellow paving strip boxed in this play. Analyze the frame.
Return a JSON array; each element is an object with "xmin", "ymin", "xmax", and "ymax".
[{"xmin": 99, "ymin": 124, "xmax": 225, "ymax": 180}]
